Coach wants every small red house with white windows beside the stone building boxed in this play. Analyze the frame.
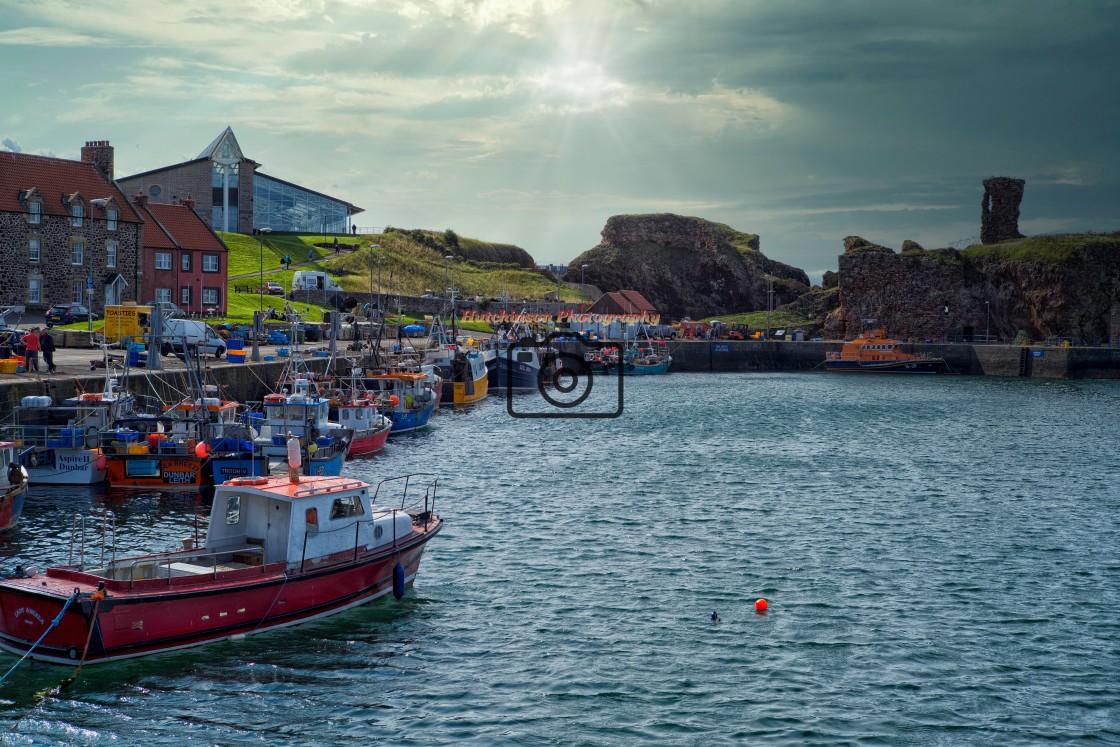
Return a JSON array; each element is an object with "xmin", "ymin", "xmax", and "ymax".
[{"xmin": 133, "ymin": 195, "xmax": 230, "ymax": 315}]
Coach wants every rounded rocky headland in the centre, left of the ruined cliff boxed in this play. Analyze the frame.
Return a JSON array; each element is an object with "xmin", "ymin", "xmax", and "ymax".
[{"xmin": 568, "ymin": 213, "xmax": 809, "ymax": 319}]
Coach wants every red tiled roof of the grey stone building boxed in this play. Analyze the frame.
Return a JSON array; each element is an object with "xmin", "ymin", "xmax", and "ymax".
[{"xmin": 0, "ymin": 151, "xmax": 141, "ymax": 223}]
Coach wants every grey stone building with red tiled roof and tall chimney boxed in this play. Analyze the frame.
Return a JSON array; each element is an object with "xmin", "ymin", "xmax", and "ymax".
[{"xmin": 0, "ymin": 140, "xmax": 144, "ymax": 314}]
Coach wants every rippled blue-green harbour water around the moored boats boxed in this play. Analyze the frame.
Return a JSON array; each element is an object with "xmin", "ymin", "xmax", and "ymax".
[{"xmin": 0, "ymin": 374, "xmax": 1120, "ymax": 746}]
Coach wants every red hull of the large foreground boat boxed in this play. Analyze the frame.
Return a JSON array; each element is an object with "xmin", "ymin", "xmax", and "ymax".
[{"xmin": 0, "ymin": 530, "xmax": 440, "ymax": 664}]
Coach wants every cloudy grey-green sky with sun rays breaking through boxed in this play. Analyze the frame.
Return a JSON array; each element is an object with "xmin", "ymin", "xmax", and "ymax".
[{"xmin": 0, "ymin": 0, "xmax": 1120, "ymax": 279}]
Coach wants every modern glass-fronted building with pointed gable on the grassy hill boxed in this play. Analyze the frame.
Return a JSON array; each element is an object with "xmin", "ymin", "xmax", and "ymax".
[{"xmin": 118, "ymin": 127, "xmax": 363, "ymax": 233}]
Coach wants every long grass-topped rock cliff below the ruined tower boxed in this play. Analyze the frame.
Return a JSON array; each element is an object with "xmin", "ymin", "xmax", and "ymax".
[{"xmin": 824, "ymin": 233, "xmax": 1120, "ymax": 342}]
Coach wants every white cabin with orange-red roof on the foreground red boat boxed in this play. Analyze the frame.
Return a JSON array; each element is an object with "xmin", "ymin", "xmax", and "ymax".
[{"xmin": 206, "ymin": 476, "xmax": 412, "ymax": 564}]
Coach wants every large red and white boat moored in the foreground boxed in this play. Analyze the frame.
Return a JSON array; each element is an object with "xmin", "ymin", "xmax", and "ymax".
[{"xmin": 0, "ymin": 461, "xmax": 442, "ymax": 664}]
